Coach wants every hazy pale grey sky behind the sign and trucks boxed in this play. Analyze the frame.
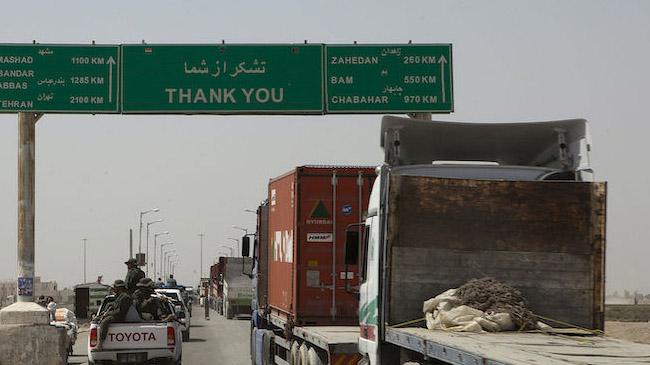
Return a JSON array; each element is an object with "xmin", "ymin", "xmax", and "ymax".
[{"xmin": 0, "ymin": 0, "xmax": 650, "ymax": 292}]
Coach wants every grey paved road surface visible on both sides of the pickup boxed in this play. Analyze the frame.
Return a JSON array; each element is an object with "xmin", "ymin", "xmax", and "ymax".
[{"xmin": 68, "ymin": 307, "xmax": 251, "ymax": 365}]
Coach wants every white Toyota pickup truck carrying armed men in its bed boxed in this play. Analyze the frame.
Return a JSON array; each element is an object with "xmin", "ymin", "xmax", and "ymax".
[{"xmin": 88, "ymin": 295, "xmax": 183, "ymax": 365}]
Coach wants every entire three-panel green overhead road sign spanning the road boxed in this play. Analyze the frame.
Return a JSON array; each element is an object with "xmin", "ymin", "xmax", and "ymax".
[{"xmin": 0, "ymin": 44, "xmax": 454, "ymax": 114}]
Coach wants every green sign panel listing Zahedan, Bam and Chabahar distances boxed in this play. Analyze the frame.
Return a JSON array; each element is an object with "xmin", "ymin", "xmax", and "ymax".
[{"xmin": 325, "ymin": 44, "xmax": 454, "ymax": 113}]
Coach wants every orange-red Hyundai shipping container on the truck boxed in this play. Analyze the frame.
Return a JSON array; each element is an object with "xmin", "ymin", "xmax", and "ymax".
[{"xmin": 268, "ymin": 166, "xmax": 375, "ymax": 325}]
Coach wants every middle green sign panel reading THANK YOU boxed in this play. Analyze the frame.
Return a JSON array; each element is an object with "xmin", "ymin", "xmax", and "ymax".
[{"xmin": 122, "ymin": 44, "xmax": 324, "ymax": 114}]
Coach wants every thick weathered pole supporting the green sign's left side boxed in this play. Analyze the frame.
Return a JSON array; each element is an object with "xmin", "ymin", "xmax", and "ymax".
[{"xmin": 16, "ymin": 113, "xmax": 43, "ymax": 302}]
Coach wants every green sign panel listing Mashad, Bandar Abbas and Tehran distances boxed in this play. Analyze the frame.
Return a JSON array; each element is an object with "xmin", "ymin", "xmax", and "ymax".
[{"xmin": 0, "ymin": 44, "xmax": 120, "ymax": 113}]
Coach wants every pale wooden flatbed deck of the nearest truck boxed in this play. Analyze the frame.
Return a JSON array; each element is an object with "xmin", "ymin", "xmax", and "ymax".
[{"xmin": 386, "ymin": 328, "xmax": 650, "ymax": 365}]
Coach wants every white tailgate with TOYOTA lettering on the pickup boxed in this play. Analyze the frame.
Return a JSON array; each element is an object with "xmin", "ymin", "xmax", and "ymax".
[{"xmin": 103, "ymin": 323, "xmax": 167, "ymax": 350}]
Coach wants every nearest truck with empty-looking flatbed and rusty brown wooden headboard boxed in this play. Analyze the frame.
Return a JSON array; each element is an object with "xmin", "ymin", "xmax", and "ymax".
[{"xmin": 346, "ymin": 116, "xmax": 650, "ymax": 365}]
